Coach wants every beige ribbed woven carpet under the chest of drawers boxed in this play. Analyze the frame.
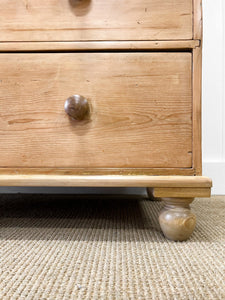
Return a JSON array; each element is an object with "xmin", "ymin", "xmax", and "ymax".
[{"xmin": 0, "ymin": 195, "xmax": 225, "ymax": 300}]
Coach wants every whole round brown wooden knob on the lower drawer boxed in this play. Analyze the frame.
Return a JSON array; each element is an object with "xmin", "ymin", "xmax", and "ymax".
[{"xmin": 64, "ymin": 95, "xmax": 90, "ymax": 121}]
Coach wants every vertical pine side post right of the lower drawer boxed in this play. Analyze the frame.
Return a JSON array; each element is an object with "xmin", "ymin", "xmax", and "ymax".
[{"xmin": 193, "ymin": 47, "xmax": 202, "ymax": 175}]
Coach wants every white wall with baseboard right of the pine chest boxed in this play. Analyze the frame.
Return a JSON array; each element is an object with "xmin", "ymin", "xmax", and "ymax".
[{"xmin": 202, "ymin": 0, "xmax": 225, "ymax": 194}]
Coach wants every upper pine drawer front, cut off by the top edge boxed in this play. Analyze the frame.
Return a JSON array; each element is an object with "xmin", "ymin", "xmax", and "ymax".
[{"xmin": 0, "ymin": 0, "xmax": 192, "ymax": 41}]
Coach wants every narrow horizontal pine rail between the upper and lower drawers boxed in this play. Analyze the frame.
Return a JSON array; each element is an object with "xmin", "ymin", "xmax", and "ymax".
[{"xmin": 0, "ymin": 40, "xmax": 200, "ymax": 52}]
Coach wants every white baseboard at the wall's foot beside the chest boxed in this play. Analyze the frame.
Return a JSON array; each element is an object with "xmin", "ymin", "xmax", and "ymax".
[{"xmin": 202, "ymin": 162, "xmax": 225, "ymax": 195}]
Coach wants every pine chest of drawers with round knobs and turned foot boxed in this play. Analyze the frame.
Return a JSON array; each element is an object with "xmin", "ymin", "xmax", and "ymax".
[{"xmin": 0, "ymin": 0, "xmax": 211, "ymax": 240}]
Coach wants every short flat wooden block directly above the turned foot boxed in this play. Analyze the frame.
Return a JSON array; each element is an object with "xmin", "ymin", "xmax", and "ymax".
[{"xmin": 153, "ymin": 187, "xmax": 211, "ymax": 198}]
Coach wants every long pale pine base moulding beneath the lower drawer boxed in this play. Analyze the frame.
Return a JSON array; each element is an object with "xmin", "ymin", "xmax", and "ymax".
[{"xmin": 0, "ymin": 173, "xmax": 212, "ymax": 188}]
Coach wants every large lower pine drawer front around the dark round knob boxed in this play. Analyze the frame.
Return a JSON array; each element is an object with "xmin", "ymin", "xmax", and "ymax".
[{"xmin": 0, "ymin": 52, "xmax": 192, "ymax": 168}]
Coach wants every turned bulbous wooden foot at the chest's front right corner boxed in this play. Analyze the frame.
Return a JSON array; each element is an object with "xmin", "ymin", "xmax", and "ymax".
[{"xmin": 159, "ymin": 198, "xmax": 196, "ymax": 241}]
